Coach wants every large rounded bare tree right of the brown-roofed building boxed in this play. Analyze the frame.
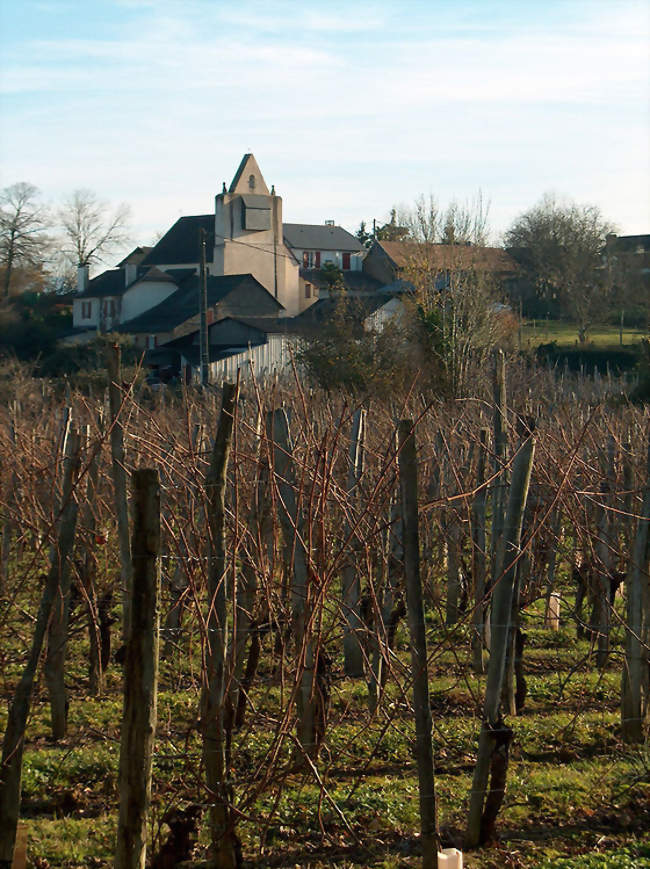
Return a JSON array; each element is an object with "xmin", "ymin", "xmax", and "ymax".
[{"xmin": 505, "ymin": 194, "xmax": 613, "ymax": 343}]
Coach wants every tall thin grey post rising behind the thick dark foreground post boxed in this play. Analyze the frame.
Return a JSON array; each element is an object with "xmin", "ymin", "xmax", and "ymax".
[{"xmin": 106, "ymin": 344, "xmax": 132, "ymax": 639}]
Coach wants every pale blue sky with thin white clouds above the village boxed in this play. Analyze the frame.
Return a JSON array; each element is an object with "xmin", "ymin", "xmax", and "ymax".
[{"xmin": 0, "ymin": 0, "xmax": 650, "ymax": 258}]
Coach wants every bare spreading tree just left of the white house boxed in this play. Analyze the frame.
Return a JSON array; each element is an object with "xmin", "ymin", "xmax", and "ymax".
[{"xmin": 59, "ymin": 189, "xmax": 130, "ymax": 266}]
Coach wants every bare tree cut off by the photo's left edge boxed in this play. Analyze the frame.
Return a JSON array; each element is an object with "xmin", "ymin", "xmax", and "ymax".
[{"xmin": 0, "ymin": 181, "xmax": 49, "ymax": 298}]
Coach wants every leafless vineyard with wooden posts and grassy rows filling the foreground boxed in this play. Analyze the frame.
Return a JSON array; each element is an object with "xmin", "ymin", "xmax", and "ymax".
[{"xmin": 0, "ymin": 352, "xmax": 650, "ymax": 869}]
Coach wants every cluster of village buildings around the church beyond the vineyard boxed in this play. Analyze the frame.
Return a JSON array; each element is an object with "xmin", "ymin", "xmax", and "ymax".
[{"xmin": 36, "ymin": 154, "xmax": 650, "ymax": 383}]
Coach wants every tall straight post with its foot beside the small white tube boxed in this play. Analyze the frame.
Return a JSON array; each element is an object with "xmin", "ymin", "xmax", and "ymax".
[{"xmin": 398, "ymin": 419, "xmax": 440, "ymax": 869}]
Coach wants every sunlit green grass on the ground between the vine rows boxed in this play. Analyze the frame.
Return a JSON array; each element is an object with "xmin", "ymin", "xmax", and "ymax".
[{"xmin": 0, "ymin": 580, "xmax": 650, "ymax": 869}]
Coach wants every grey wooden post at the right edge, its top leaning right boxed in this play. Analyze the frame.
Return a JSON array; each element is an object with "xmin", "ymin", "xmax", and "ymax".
[{"xmin": 621, "ymin": 428, "xmax": 650, "ymax": 743}]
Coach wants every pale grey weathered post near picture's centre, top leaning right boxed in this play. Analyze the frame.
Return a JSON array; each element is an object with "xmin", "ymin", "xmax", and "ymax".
[{"xmin": 341, "ymin": 408, "xmax": 366, "ymax": 677}]
